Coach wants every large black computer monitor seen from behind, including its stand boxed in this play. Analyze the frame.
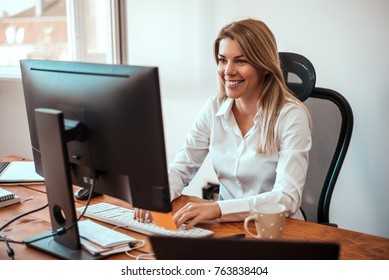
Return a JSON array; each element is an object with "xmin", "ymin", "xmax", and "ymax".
[{"xmin": 20, "ymin": 60, "xmax": 171, "ymax": 258}]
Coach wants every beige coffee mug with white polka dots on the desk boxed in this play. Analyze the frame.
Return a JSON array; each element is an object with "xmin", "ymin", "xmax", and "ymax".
[{"xmin": 244, "ymin": 203, "xmax": 286, "ymax": 240}]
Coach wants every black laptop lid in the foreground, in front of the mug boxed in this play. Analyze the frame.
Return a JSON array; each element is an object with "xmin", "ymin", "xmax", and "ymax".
[{"xmin": 149, "ymin": 236, "xmax": 339, "ymax": 260}]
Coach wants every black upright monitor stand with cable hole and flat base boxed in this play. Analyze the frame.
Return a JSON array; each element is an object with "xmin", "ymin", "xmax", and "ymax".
[{"xmin": 24, "ymin": 109, "xmax": 102, "ymax": 260}]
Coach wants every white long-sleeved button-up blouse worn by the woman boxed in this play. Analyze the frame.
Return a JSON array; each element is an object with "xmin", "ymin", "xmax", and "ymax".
[{"xmin": 169, "ymin": 97, "xmax": 311, "ymax": 221}]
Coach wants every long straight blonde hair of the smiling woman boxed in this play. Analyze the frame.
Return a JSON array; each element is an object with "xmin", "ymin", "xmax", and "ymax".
[{"xmin": 214, "ymin": 19, "xmax": 309, "ymax": 153}]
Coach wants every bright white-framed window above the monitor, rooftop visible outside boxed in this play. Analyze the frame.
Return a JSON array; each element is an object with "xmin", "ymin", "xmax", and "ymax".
[{"xmin": 0, "ymin": 0, "xmax": 121, "ymax": 77}]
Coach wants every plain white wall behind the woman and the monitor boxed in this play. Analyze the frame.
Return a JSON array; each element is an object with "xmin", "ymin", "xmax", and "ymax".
[{"xmin": 0, "ymin": 0, "xmax": 389, "ymax": 237}]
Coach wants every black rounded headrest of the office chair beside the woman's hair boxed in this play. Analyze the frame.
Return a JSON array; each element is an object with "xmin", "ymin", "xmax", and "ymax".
[{"xmin": 279, "ymin": 52, "xmax": 316, "ymax": 101}]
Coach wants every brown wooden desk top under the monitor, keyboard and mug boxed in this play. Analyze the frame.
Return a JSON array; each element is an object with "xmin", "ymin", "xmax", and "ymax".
[{"xmin": 0, "ymin": 185, "xmax": 389, "ymax": 260}]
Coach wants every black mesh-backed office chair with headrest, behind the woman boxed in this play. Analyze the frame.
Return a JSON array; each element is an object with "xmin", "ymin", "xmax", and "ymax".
[{"xmin": 280, "ymin": 52, "xmax": 354, "ymax": 226}]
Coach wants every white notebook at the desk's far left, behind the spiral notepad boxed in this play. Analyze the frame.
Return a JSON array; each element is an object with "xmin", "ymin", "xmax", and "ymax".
[{"xmin": 0, "ymin": 161, "xmax": 44, "ymax": 185}]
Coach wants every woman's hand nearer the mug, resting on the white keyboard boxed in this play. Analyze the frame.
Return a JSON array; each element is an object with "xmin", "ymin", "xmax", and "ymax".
[{"xmin": 173, "ymin": 202, "xmax": 221, "ymax": 229}]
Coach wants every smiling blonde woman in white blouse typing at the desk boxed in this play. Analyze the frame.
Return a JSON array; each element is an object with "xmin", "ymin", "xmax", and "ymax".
[{"xmin": 135, "ymin": 19, "xmax": 311, "ymax": 228}]
